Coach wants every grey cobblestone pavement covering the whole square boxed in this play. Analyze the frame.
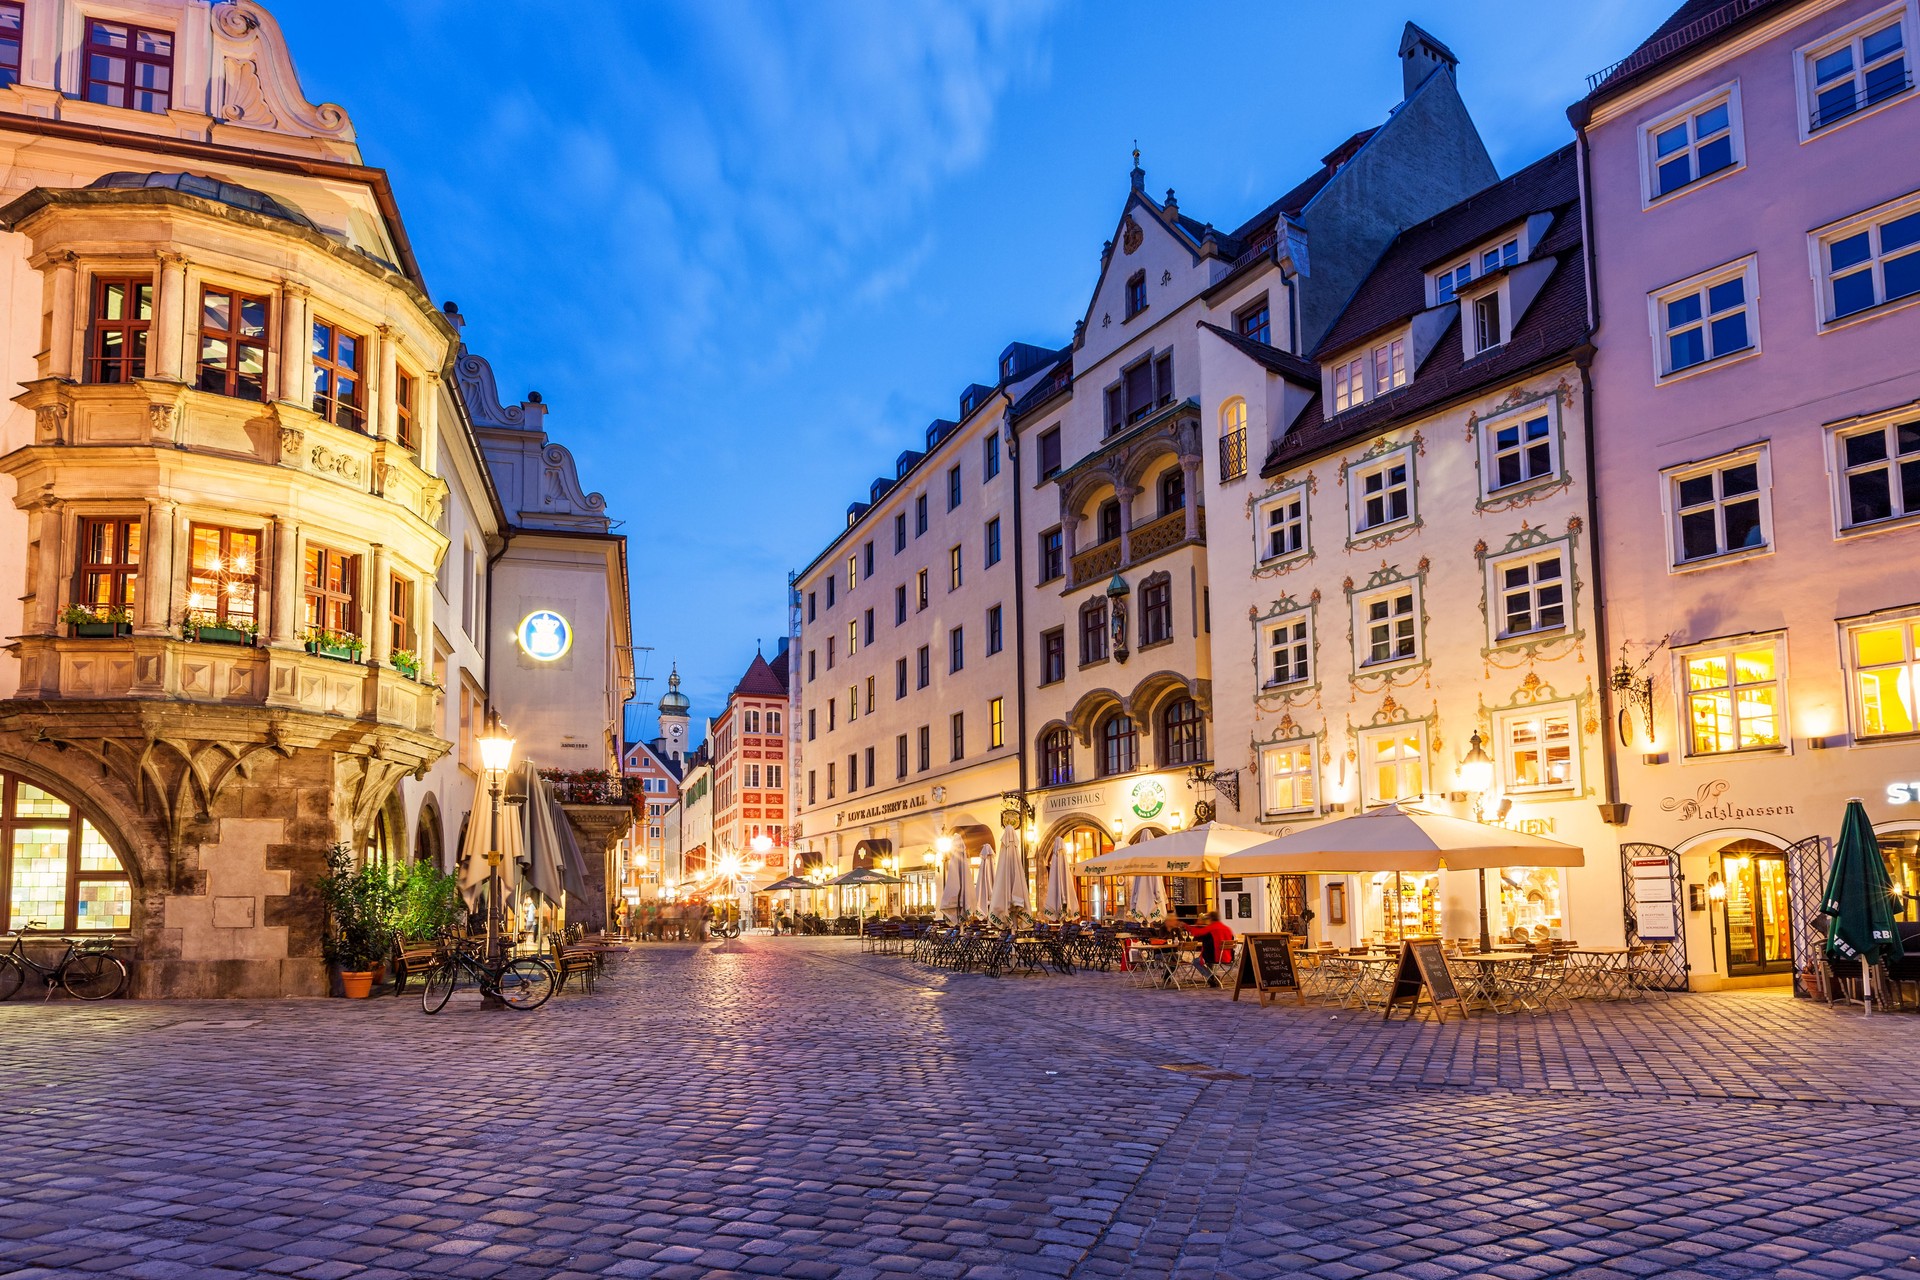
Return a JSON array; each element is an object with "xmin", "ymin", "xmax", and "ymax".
[{"xmin": 0, "ymin": 936, "xmax": 1920, "ymax": 1280}]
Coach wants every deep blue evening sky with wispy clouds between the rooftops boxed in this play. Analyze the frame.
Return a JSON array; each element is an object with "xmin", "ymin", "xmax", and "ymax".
[{"xmin": 269, "ymin": 0, "xmax": 1678, "ymax": 737}]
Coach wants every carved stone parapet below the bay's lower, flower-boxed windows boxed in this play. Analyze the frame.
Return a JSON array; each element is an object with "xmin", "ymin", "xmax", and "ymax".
[{"xmin": 10, "ymin": 635, "xmax": 442, "ymax": 735}]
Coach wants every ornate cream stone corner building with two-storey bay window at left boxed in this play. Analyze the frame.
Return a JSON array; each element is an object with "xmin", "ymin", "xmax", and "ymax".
[{"xmin": 0, "ymin": 0, "xmax": 626, "ymax": 996}]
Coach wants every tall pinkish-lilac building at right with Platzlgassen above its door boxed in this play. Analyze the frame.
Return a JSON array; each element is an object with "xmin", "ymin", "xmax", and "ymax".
[{"xmin": 1571, "ymin": 0, "xmax": 1920, "ymax": 988}]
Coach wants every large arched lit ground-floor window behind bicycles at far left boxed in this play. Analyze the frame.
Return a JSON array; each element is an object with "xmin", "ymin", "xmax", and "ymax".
[{"xmin": 0, "ymin": 773, "xmax": 132, "ymax": 933}]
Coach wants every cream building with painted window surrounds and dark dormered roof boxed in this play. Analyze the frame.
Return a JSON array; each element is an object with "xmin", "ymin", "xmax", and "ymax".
[{"xmin": 1208, "ymin": 148, "xmax": 1620, "ymax": 944}]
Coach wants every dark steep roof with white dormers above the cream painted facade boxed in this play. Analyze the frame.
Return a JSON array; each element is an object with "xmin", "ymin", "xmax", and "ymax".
[{"xmin": 1261, "ymin": 148, "xmax": 1588, "ymax": 476}]
